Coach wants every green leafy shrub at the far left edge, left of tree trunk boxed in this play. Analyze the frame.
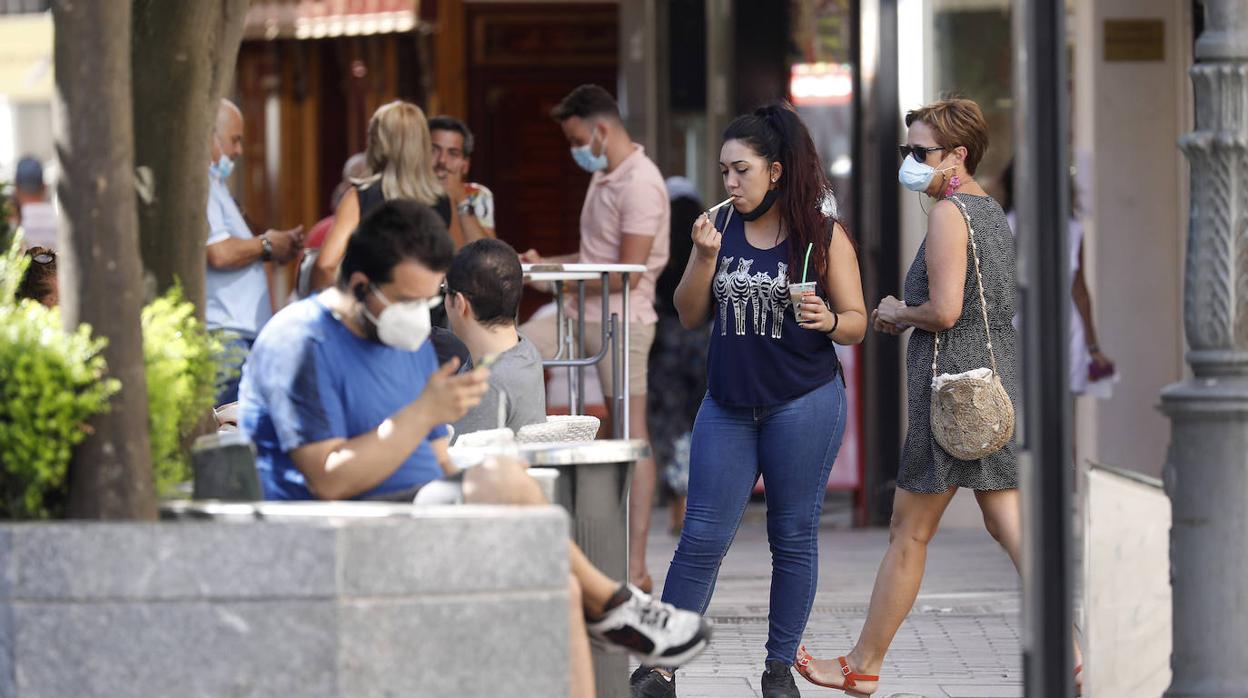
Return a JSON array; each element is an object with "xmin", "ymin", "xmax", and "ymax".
[{"xmin": 0, "ymin": 239, "xmax": 121, "ymax": 519}]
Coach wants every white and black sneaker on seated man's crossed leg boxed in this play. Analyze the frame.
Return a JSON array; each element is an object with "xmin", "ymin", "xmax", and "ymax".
[{"xmin": 585, "ymin": 584, "xmax": 710, "ymax": 668}]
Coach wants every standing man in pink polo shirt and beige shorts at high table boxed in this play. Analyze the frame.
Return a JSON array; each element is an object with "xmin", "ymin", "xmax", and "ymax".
[{"xmin": 520, "ymin": 85, "xmax": 671, "ymax": 589}]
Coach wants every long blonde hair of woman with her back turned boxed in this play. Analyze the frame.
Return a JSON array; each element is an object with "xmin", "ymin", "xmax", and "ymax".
[{"xmin": 361, "ymin": 100, "xmax": 442, "ymax": 206}]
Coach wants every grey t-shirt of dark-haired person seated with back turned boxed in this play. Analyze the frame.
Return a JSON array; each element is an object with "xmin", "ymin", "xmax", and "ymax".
[{"xmin": 456, "ymin": 337, "xmax": 545, "ymax": 435}]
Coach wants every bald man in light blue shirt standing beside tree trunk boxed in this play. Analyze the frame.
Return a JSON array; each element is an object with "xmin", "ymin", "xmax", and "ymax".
[{"xmin": 205, "ymin": 100, "xmax": 303, "ymax": 405}]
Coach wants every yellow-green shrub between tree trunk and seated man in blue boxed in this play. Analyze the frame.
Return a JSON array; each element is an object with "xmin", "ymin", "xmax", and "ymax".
[{"xmin": 142, "ymin": 286, "xmax": 222, "ymax": 494}]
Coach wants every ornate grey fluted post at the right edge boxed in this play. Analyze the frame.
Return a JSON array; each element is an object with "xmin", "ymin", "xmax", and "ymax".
[{"xmin": 1162, "ymin": 0, "xmax": 1248, "ymax": 698}]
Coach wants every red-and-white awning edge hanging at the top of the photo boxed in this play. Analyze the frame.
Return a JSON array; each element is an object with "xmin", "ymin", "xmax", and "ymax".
[{"xmin": 243, "ymin": 0, "xmax": 421, "ymax": 41}]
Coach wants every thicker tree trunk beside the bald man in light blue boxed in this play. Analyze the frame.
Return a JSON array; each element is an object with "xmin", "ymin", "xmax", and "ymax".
[{"xmin": 131, "ymin": 0, "xmax": 250, "ymax": 312}]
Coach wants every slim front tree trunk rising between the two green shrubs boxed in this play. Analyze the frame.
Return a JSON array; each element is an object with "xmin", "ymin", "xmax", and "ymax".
[{"xmin": 52, "ymin": 0, "xmax": 156, "ymax": 519}]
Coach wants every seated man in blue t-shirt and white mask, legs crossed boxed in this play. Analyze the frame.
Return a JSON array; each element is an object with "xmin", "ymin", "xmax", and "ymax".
[{"xmin": 238, "ymin": 200, "xmax": 710, "ymax": 687}]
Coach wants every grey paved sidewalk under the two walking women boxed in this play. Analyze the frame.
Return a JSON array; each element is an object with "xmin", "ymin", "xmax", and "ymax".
[{"xmin": 633, "ymin": 502, "xmax": 1022, "ymax": 698}]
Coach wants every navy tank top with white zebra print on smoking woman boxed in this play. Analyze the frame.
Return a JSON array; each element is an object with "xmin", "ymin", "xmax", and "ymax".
[{"xmin": 706, "ymin": 206, "xmax": 840, "ymax": 407}]
